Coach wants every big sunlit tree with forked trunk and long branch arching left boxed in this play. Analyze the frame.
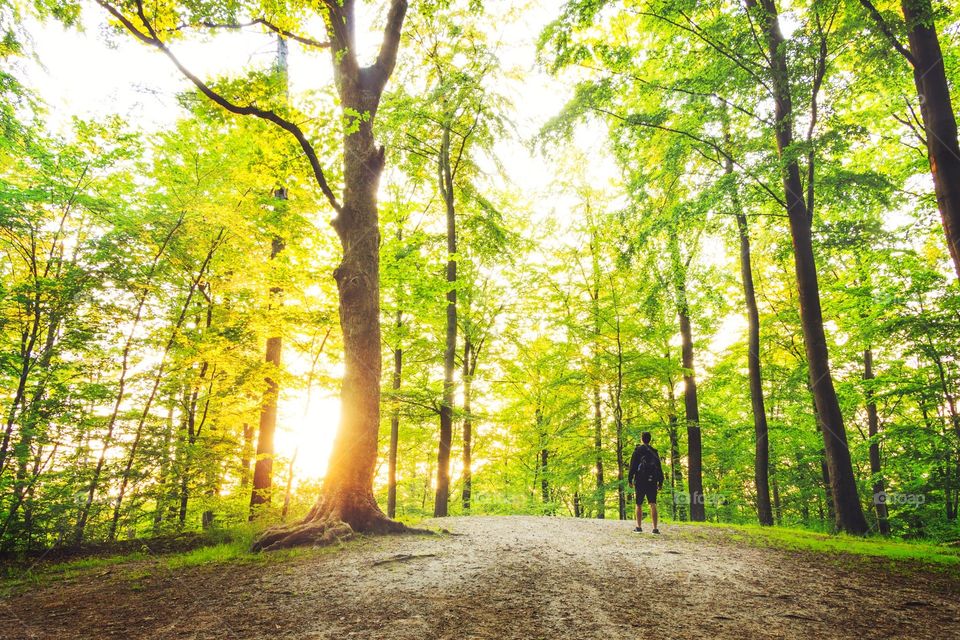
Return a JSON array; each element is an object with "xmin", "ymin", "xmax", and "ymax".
[{"xmin": 98, "ymin": 0, "xmax": 407, "ymax": 549}]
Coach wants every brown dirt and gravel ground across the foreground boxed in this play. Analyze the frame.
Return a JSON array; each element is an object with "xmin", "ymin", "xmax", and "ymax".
[{"xmin": 0, "ymin": 516, "xmax": 960, "ymax": 640}]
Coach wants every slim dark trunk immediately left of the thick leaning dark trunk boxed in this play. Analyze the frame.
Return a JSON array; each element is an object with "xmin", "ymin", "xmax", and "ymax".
[{"xmin": 727, "ymin": 180, "xmax": 773, "ymax": 525}]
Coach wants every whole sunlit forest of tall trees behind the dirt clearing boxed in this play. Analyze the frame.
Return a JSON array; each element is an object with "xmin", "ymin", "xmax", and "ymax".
[{"xmin": 0, "ymin": 0, "xmax": 960, "ymax": 556}]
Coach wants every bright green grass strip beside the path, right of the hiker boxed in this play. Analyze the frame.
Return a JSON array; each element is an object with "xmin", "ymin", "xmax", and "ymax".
[{"xmin": 674, "ymin": 522, "xmax": 960, "ymax": 575}]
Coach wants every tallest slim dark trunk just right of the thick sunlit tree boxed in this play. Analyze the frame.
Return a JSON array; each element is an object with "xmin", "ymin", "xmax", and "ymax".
[{"xmin": 433, "ymin": 126, "xmax": 457, "ymax": 517}]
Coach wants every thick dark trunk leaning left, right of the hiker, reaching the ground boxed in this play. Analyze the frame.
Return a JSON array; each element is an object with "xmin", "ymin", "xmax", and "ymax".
[{"xmin": 746, "ymin": 0, "xmax": 868, "ymax": 534}]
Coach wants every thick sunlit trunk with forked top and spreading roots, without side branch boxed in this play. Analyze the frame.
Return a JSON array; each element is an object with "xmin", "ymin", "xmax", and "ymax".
[{"xmin": 253, "ymin": 0, "xmax": 409, "ymax": 550}]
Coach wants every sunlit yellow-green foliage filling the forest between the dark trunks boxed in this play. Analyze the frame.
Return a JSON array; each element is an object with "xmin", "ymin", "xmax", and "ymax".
[{"xmin": 0, "ymin": 0, "xmax": 960, "ymax": 556}]
